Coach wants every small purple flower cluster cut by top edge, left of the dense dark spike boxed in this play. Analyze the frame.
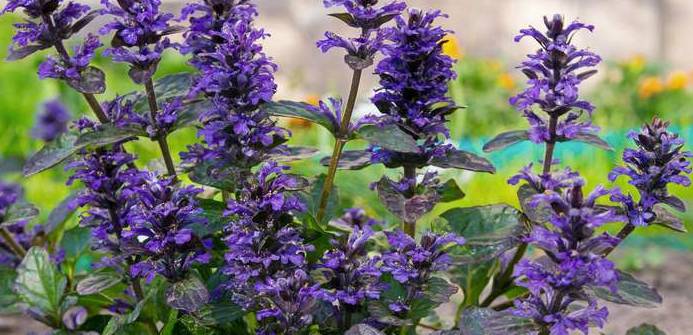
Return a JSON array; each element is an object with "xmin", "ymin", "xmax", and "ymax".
[{"xmin": 317, "ymin": 0, "xmax": 407, "ymax": 70}]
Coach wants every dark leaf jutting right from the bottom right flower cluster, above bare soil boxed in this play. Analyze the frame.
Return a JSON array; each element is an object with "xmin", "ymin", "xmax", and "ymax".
[{"xmin": 591, "ymin": 271, "xmax": 662, "ymax": 308}]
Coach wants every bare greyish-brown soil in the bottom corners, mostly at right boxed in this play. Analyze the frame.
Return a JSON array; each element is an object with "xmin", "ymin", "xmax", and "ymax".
[{"xmin": 0, "ymin": 252, "xmax": 693, "ymax": 335}]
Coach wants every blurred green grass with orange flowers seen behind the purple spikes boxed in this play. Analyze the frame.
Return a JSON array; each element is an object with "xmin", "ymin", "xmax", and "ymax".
[{"xmin": 0, "ymin": 16, "xmax": 693, "ymax": 267}]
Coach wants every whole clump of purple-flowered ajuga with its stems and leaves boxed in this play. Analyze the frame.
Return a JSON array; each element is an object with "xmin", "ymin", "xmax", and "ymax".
[{"xmin": 0, "ymin": 0, "xmax": 691, "ymax": 335}]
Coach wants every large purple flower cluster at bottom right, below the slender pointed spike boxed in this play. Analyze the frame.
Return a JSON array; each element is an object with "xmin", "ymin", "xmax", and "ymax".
[{"xmin": 513, "ymin": 173, "xmax": 623, "ymax": 335}]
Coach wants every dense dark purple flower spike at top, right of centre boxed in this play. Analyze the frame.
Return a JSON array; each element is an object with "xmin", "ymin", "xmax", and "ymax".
[{"xmin": 372, "ymin": 9, "xmax": 457, "ymax": 164}]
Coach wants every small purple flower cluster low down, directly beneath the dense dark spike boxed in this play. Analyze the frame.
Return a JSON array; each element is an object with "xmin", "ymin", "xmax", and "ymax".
[{"xmin": 381, "ymin": 230, "xmax": 465, "ymax": 316}]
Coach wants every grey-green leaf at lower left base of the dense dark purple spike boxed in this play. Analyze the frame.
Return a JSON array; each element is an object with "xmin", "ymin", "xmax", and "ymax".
[{"xmin": 356, "ymin": 124, "xmax": 419, "ymax": 153}]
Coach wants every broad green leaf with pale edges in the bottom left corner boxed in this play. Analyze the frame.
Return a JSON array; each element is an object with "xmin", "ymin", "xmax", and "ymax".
[{"xmin": 15, "ymin": 247, "xmax": 67, "ymax": 322}]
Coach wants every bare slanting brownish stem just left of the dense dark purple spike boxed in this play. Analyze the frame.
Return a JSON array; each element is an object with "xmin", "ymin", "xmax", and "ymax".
[{"xmin": 317, "ymin": 70, "xmax": 363, "ymax": 222}]
